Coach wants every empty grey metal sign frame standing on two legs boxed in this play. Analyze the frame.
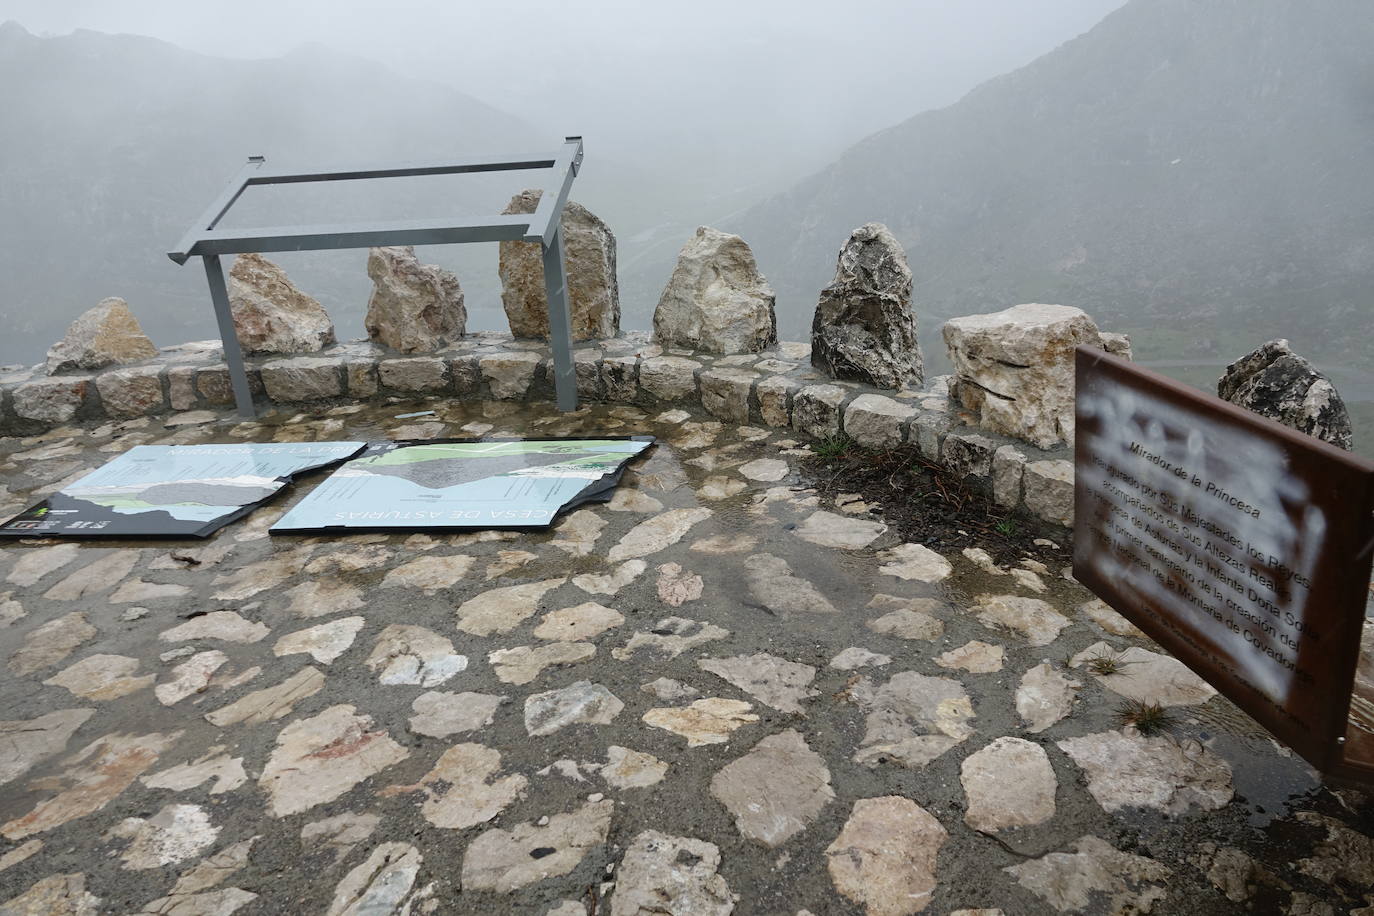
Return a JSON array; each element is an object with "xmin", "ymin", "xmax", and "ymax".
[{"xmin": 168, "ymin": 137, "xmax": 583, "ymax": 417}]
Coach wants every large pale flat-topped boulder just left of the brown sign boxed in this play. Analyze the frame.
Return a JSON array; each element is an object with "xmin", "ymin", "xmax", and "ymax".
[{"xmin": 944, "ymin": 304, "xmax": 1104, "ymax": 449}]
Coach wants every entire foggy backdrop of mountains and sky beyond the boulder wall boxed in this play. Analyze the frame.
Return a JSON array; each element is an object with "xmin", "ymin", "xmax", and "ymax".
[{"xmin": 0, "ymin": 0, "xmax": 1374, "ymax": 387}]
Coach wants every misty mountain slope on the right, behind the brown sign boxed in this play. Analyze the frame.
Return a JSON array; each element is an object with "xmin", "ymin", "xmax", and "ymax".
[{"xmin": 731, "ymin": 0, "xmax": 1374, "ymax": 356}]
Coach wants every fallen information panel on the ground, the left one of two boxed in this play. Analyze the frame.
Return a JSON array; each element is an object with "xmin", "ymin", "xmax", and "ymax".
[{"xmin": 0, "ymin": 442, "xmax": 367, "ymax": 537}]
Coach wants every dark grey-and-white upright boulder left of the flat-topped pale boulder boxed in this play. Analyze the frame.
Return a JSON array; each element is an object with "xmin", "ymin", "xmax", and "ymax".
[{"xmin": 811, "ymin": 222, "xmax": 925, "ymax": 389}]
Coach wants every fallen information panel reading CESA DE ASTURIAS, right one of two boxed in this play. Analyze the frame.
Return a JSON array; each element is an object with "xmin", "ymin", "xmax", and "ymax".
[{"xmin": 268, "ymin": 435, "xmax": 654, "ymax": 534}]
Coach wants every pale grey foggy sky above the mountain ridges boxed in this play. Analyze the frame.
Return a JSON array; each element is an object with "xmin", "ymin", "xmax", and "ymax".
[{"xmin": 0, "ymin": 0, "xmax": 1123, "ymax": 183}]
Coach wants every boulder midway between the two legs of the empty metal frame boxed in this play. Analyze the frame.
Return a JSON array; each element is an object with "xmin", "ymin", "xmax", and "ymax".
[{"xmin": 364, "ymin": 246, "xmax": 467, "ymax": 353}]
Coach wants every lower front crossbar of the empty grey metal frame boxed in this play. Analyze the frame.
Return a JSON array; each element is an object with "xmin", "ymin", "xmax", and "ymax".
[{"xmin": 187, "ymin": 213, "xmax": 529, "ymax": 255}]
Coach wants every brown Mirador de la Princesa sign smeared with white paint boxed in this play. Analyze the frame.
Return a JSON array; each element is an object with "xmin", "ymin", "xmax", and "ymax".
[{"xmin": 1073, "ymin": 347, "xmax": 1374, "ymax": 779}]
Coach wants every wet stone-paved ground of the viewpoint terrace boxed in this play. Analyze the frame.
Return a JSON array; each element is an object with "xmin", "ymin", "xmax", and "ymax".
[{"xmin": 0, "ymin": 404, "xmax": 1374, "ymax": 916}]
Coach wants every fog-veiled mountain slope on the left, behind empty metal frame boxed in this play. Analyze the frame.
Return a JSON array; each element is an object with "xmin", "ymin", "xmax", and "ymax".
[{"xmin": 0, "ymin": 23, "xmax": 541, "ymax": 363}]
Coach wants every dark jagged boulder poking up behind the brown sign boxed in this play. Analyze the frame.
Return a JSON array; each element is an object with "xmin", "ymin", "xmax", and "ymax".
[{"xmin": 1216, "ymin": 341, "xmax": 1352, "ymax": 450}]
